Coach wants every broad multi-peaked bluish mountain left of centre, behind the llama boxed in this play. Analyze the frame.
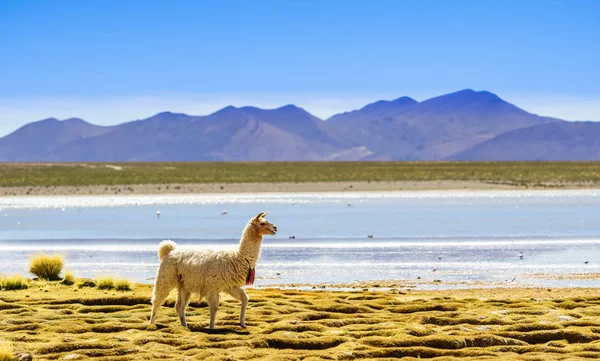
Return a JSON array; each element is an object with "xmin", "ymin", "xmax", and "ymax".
[{"xmin": 32, "ymin": 105, "xmax": 346, "ymax": 161}]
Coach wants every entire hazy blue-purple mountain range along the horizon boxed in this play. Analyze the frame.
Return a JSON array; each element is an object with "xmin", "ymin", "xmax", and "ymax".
[{"xmin": 0, "ymin": 89, "xmax": 600, "ymax": 162}]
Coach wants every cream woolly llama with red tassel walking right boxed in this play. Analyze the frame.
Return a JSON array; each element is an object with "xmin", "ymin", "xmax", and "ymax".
[{"xmin": 150, "ymin": 212, "xmax": 277, "ymax": 329}]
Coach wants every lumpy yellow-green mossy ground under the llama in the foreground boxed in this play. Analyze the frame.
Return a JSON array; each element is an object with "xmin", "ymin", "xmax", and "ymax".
[{"xmin": 0, "ymin": 281, "xmax": 600, "ymax": 360}]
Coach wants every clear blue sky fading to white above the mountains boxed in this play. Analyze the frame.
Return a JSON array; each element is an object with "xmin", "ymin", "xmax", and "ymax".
[{"xmin": 0, "ymin": 0, "xmax": 600, "ymax": 135}]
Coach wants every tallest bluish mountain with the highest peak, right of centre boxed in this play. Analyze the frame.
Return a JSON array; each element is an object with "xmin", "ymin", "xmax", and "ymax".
[{"xmin": 327, "ymin": 89, "xmax": 560, "ymax": 160}]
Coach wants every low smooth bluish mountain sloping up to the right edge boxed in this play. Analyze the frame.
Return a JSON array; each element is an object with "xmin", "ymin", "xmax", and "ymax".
[{"xmin": 450, "ymin": 122, "xmax": 600, "ymax": 161}]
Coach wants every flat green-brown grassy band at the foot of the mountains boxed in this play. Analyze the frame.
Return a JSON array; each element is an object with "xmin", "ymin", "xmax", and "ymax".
[{"xmin": 0, "ymin": 162, "xmax": 600, "ymax": 187}]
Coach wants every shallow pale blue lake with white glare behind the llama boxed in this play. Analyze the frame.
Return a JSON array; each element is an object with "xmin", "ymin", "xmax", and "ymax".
[{"xmin": 0, "ymin": 190, "xmax": 600, "ymax": 288}]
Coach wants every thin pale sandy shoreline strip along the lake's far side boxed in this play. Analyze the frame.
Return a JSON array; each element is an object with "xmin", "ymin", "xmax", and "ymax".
[{"xmin": 0, "ymin": 180, "xmax": 600, "ymax": 196}]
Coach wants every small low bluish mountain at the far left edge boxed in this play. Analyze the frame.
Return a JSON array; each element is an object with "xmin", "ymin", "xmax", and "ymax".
[{"xmin": 0, "ymin": 118, "xmax": 113, "ymax": 162}]
